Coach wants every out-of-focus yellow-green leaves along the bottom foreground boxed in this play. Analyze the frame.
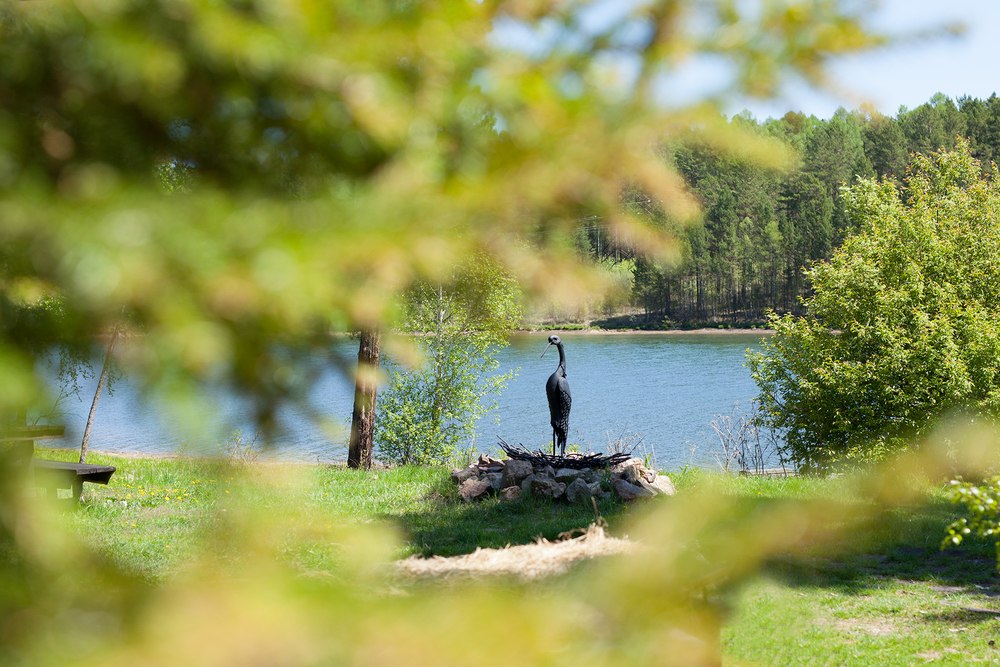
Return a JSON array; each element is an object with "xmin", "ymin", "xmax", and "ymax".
[{"xmin": 0, "ymin": 467, "xmax": 815, "ymax": 666}]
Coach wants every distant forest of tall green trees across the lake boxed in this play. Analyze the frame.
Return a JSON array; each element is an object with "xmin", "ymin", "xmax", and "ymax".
[{"xmin": 581, "ymin": 93, "xmax": 1000, "ymax": 325}]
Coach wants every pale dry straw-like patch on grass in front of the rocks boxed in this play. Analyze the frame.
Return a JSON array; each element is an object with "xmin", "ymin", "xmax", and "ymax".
[{"xmin": 396, "ymin": 524, "xmax": 636, "ymax": 581}]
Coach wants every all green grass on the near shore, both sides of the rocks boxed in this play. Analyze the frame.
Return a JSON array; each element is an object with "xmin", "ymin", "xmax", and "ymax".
[{"xmin": 39, "ymin": 452, "xmax": 1000, "ymax": 665}]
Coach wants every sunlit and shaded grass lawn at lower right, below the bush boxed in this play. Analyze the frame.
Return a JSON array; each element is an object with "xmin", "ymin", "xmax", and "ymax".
[{"xmin": 708, "ymin": 479, "xmax": 1000, "ymax": 666}]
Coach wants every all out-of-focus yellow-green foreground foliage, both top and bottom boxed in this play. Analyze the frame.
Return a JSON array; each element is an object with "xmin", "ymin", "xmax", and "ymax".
[{"xmin": 0, "ymin": 0, "xmax": 900, "ymax": 666}]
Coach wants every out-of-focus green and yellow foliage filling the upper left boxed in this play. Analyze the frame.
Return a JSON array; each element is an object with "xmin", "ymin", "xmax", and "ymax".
[{"xmin": 0, "ymin": 0, "xmax": 879, "ymax": 426}]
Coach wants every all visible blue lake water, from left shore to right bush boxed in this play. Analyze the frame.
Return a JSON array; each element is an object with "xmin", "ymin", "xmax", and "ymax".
[{"xmin": 37, "ymin": 332, "xmax": 761, "ymax": 468}]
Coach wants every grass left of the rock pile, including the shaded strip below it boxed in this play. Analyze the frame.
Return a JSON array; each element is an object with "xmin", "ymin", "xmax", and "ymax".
[{"xmin": 45, "ymin": 450, "xmax": 625, "ymax": 580}]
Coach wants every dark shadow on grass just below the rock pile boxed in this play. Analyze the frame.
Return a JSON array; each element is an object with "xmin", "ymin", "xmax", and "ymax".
[{"xmin": 391, "ymin": 490, "xmax": 626, "ymax": 556}]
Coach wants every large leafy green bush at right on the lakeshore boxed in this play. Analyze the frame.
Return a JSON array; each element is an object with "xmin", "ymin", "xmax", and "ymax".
[{"xmin": 749, "ymin": 141, "xmax": 1000, "ymax": 468}]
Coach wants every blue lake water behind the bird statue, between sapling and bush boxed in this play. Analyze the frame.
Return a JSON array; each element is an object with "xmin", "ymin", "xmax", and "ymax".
[{"xmin": 492, "ymin": 333, "xmax": 761, "ymax": 468}]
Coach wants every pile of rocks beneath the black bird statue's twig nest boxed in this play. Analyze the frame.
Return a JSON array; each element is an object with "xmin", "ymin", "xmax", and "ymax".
[{"xmin": 451, "ymin": 454, "xmax": 675, "ymax": 503}]
